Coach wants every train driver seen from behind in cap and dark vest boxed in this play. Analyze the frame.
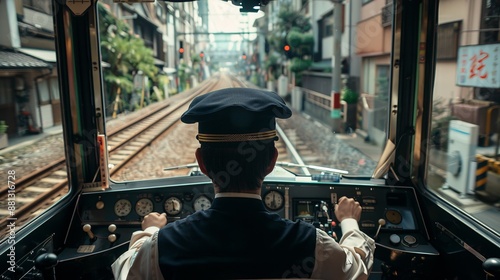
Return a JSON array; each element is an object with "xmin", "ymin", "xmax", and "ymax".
[{"xmin": 112, "ymin": 88, "xmax": 375, "ymax": 279}]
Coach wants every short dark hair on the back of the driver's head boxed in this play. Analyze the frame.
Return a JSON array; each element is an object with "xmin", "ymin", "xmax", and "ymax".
[{"xmin": 200, "ymin": 140, "xmax": 275, "ymax": 192}]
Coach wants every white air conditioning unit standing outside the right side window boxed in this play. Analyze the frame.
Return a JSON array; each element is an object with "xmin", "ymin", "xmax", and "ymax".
[{"xmin": 445, "ymin": 120, "xmax": 479, "ymax": 196}]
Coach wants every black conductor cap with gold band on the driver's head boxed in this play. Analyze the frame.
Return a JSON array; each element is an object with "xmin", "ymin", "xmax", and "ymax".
[{"xmin": 181, "ymin": 88, "xmax": 292, "ymax": 143}]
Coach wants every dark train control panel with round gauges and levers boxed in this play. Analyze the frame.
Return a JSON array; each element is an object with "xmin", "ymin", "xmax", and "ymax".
[{"xmin": 46, "ymin": 178, "xmax": 438, "ymax": 277}]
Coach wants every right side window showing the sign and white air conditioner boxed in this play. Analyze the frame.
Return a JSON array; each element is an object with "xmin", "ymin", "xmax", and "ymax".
[{"xmin": 427, "ymin": 0, "xmax": 500, "ymax": 233}]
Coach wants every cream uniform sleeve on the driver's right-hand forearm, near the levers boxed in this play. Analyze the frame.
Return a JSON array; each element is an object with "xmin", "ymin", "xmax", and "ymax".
[{"xmin": 311, "ymin": 219, "xmax": 375, "ymax": 280}]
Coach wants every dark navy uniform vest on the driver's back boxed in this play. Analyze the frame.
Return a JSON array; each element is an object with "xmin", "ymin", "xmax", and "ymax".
[{"xmin": 158, "ymin": 197, "xmax": 316, "ymax": 279}]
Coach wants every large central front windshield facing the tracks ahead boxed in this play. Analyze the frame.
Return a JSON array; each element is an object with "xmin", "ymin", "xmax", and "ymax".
[{"xmin": 99, "ymin": 1, "xmax": 382, "ymax": 182}]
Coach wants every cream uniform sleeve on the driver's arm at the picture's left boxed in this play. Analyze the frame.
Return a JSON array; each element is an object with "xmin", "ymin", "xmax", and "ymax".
[{"xmin": 111, "ymin": 227, "xmax": 163, "ymax": 280}]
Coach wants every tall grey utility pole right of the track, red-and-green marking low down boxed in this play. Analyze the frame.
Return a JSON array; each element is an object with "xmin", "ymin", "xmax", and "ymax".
[{"xmin": 330, "ymin": 0, "xmax": 343, "ymax": 132}]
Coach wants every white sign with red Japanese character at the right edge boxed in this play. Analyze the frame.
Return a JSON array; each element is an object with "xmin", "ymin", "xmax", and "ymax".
[{"xmin": 456, "ymin": 44, "xmax": 500, "ymax": 88}]
